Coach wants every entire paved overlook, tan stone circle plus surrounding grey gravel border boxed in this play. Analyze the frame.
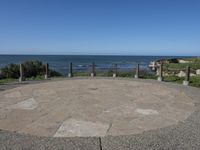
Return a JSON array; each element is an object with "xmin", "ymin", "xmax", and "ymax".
[{"xmin": 0, "ymin": 77, "xmax": 200, "ymax": 149}]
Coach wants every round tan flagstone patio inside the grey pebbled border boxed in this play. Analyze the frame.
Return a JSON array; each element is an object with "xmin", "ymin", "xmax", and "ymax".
[{"xmin": 0, "ymin": 79, "xmax": 195, "ymax": 137}]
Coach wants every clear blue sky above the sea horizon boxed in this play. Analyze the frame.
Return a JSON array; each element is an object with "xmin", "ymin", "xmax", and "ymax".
[{"xmin": 0, "ymin": 0, "xmax": 200, "ymax": 56}]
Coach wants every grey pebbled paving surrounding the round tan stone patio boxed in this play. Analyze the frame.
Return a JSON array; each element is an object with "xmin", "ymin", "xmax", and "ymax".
[{"xmin": 0, "ymin": 78, "xmax": 200, "ymax": 150}]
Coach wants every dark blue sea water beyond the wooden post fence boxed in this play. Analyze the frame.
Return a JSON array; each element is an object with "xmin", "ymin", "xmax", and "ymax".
[{"xmin": 0, "ymin": 55, "xmax": 188, "ymax": 75}]
